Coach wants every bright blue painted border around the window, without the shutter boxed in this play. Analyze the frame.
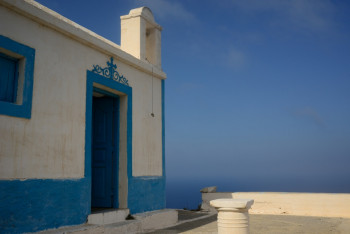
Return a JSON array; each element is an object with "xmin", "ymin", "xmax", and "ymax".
[{"xmin": 0, "ymin": 35, "xmax": 35, "ymax": 119}]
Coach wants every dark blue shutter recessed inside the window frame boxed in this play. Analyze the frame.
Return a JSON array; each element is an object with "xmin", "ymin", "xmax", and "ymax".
[{"xmin": 0, "ymin": 54, "xmax": 18, "ymax": 102}]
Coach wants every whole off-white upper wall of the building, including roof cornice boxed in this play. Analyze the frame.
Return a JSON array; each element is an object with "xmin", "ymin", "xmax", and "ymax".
[{"xmin": 0, "ymin": 0, "xmax": 166, "ymax": 179}]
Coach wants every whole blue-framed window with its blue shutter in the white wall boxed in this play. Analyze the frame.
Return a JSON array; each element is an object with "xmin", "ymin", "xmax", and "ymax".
[{"xmin": 0, "ymin": 35, "xmax": 35, "ymax": 119}]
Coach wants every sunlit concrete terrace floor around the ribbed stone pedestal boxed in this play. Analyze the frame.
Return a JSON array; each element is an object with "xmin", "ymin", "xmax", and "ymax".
[{"xmin": 148, "ymin": 211, "xmax": 350, "ymax": 234}]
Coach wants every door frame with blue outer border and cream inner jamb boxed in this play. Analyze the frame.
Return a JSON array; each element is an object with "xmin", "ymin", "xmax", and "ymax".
[{"xmin": 84, "ymin": 70, "xmax": 132, "ymax": 214}]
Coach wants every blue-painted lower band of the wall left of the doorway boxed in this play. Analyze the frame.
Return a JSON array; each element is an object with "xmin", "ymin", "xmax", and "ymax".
[{"xmin": 0, "ymin": 178, "xmax": 91, "ymax": 233}]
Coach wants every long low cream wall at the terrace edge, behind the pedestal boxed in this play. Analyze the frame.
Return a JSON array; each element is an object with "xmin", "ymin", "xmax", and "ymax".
[{"xmin": 202, "ymin": 192, "xmax": 350, "ymax": 218}]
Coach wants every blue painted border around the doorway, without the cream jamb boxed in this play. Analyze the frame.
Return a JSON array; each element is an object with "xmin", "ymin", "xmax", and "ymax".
[{"xmin": 85, "ymin": 71, "xmax": 132, "ymax": 210}]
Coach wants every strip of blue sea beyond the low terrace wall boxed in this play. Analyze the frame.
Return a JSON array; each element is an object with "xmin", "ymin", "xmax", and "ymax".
[{"xmin": 166, "ymin": 175, "xmax": 350, "ymax": 210}]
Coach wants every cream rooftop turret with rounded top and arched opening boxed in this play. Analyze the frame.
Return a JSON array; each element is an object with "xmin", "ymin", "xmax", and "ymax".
[{"xmin": 120, "ymin": 7, "xmax": 162, "ymax": 69}]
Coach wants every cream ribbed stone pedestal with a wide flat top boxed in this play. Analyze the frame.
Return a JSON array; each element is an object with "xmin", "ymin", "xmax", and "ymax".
[{"xmin": 210, "ymin": 199, "xmax": 254, "ymax": 234}]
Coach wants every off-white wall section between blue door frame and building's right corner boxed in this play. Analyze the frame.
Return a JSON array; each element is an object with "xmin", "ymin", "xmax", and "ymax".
[{"xmin": 133, "ymin": 70, "xmax": 163, "ymax": 176}]
